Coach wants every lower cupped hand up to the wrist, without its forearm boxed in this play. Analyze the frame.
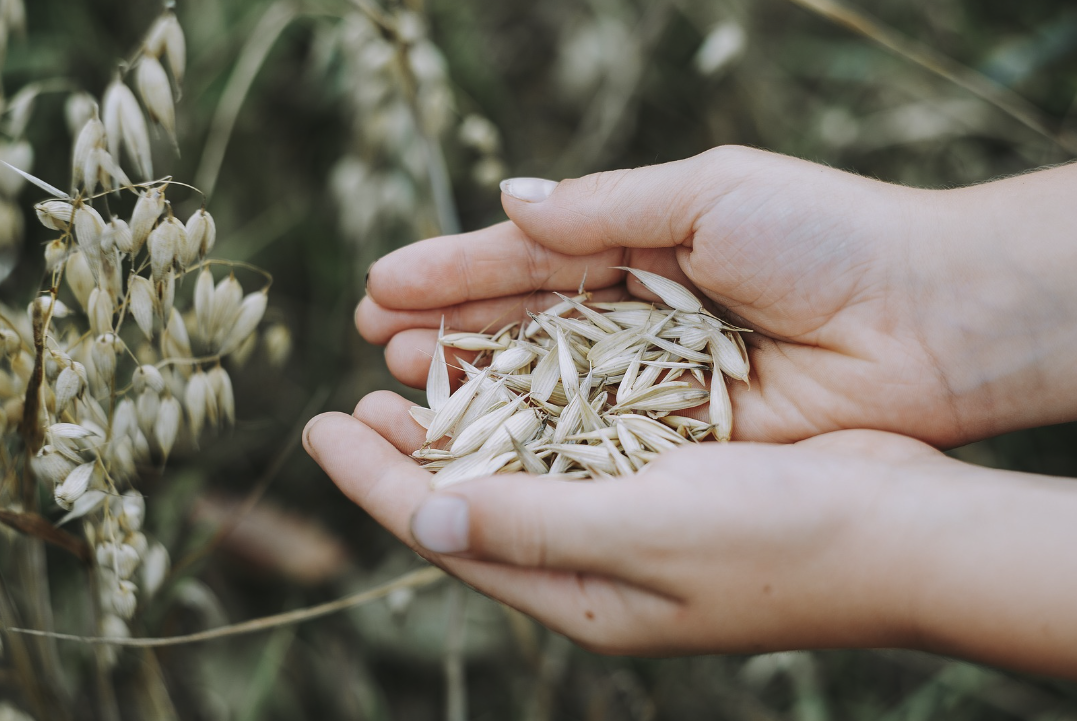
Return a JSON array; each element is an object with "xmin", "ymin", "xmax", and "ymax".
[{"xmin": 305, "ymin": 391, "xmax": 954, "ymax": 655}]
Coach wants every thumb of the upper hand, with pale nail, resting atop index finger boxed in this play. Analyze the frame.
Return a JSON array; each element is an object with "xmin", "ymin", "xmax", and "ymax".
[{"xmin": 501, "ymin": 155, "xmax": 709, "ymax": 255}]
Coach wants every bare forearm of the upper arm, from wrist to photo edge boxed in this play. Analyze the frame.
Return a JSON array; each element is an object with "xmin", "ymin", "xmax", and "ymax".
[{"xmin": 909, "ymin": 165, "xmax": 1077, "ymax": 439}]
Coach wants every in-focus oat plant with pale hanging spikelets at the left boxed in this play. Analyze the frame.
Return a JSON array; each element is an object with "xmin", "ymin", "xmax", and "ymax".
[{"xmin": 0, "ymin": 7, "xmax": 271, "ymax": 719}]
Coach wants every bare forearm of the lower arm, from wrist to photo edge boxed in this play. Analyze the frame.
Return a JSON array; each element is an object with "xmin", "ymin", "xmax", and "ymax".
[{"xmin": 882, "ymin": 462, "xmax": 1077, "ymax": 678}]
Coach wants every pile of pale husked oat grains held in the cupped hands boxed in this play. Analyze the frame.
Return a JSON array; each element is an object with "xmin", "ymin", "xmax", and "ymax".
[{"xmin": 411, "ymin": 267, "xmax": 749, "ymax": 488}]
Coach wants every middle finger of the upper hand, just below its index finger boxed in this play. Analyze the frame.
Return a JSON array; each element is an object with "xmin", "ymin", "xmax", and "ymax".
[{"xmin": 355, "ymin": 286, "xmax": 628, "ymax": 345}]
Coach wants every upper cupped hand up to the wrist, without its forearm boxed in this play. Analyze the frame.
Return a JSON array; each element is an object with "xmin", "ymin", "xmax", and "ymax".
[{"xmin": 356, "ymin": 148, "xmax": 977, "ymax": 445}]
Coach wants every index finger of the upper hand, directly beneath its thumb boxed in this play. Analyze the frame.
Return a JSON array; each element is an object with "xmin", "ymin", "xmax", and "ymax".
[{"xmin": 366, "ymin": 223, "xmax": 624, "ymax": 310}]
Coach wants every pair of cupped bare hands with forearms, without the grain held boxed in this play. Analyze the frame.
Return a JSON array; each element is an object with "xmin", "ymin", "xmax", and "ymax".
[{"xmin": 305, "ymin": 148, "xmax": 1077, "ymax": 674}]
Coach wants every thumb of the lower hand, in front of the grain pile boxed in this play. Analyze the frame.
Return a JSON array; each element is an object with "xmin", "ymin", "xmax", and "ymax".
[{"xmin": 411, "ymin": 476, "xmax": 639, "ymax": 576}]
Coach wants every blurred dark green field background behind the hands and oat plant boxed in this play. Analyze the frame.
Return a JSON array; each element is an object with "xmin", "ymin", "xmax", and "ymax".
[{"xmin": 0, "ymin": 0, "xmax": 1077, "ymax": 721}]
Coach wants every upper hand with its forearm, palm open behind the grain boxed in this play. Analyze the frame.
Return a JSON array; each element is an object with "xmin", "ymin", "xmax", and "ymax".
[{"xmin": 356, "ymin": 148, "xmax": 1077, "ymax": 446}]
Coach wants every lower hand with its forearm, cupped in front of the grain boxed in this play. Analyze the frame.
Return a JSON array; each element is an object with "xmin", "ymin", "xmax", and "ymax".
[{"xmin": 304, "ymin": 391, "xmax": 1077, "ymax": 677}]
